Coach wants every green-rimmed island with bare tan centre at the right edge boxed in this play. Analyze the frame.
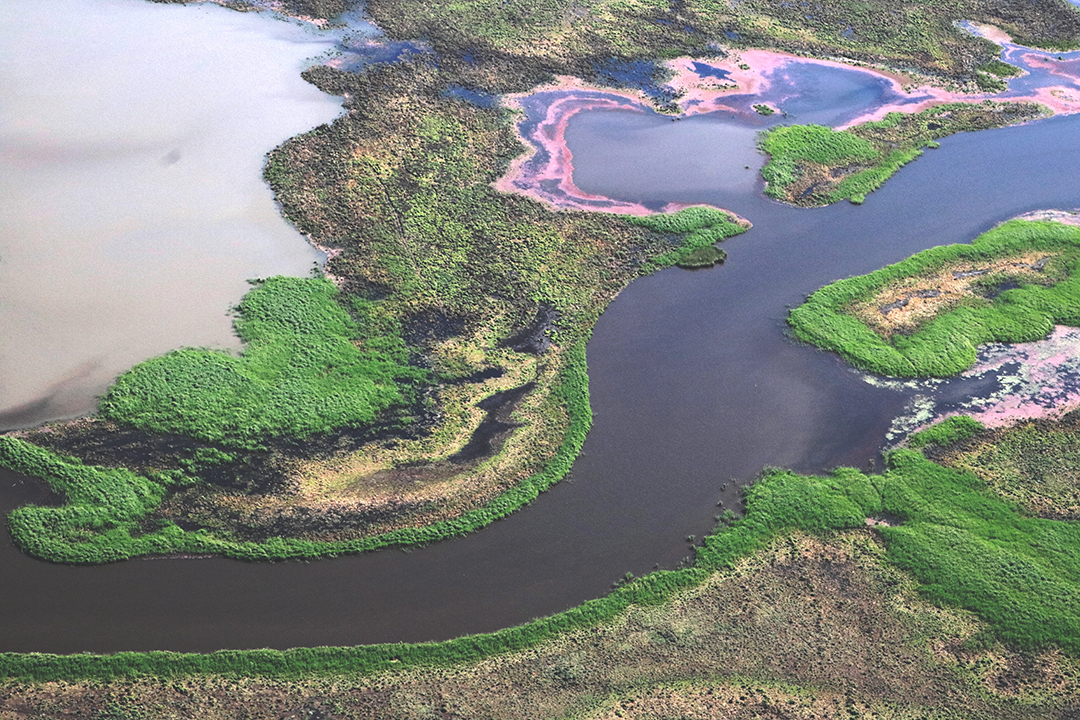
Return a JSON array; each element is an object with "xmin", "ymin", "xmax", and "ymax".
[{"xmin": 787, "ymin": 219, "xmax": 1080, "ymax": 378}]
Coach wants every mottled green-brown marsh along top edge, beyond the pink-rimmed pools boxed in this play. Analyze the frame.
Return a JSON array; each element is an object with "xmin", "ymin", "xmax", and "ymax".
[{"xmin": 366, "ymin": 0, "xmax": 1080, "ymax": 92}]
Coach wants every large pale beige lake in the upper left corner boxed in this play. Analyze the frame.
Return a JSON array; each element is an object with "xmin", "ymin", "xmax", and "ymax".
[{"xmin": 0, "ymin": 0, "xmax": 340, "ymax": 429}]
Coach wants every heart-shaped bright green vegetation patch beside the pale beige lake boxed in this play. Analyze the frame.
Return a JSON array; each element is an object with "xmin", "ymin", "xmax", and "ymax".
[{"xmin": 98, "ymin": 277, "xmax": 427, "ymax": 450}]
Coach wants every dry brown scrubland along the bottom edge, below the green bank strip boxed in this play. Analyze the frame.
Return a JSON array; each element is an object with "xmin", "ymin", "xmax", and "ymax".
[{"xmin": 12, "ymin": 530, "xmax": 1080, "ymax": 720}]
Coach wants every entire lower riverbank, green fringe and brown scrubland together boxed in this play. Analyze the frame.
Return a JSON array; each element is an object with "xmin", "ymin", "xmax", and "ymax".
[{"xmin": 0, "ymin": 415, "xmax": 1080, "ymax": 720}]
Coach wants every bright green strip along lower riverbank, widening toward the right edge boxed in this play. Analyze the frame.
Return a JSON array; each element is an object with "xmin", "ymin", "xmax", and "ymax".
[{"xmin": 0, "ymin": 418, "xmax": 1080, "ymax": 680}]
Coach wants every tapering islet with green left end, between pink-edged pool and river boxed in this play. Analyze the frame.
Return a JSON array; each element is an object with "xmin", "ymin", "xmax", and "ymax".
[{"xmin": 758, "ymin": 100, "xmax": 1049, "ymax": 206}]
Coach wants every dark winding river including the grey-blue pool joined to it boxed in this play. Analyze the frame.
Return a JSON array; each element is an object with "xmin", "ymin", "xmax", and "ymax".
[{"xmin": 0, "ymin": 3, "xmax": 1080, "ymax": 652}]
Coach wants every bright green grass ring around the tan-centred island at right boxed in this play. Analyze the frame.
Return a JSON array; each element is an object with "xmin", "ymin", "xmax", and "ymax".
[{"xmin": 788, "ymin": 220, "xmax": 1080, "ymax": 377}]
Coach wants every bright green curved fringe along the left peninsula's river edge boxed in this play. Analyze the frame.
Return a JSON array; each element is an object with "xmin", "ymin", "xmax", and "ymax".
[{"xmin": 0, "ymin": 343, "xmax": 592, "ymax": 563}]
